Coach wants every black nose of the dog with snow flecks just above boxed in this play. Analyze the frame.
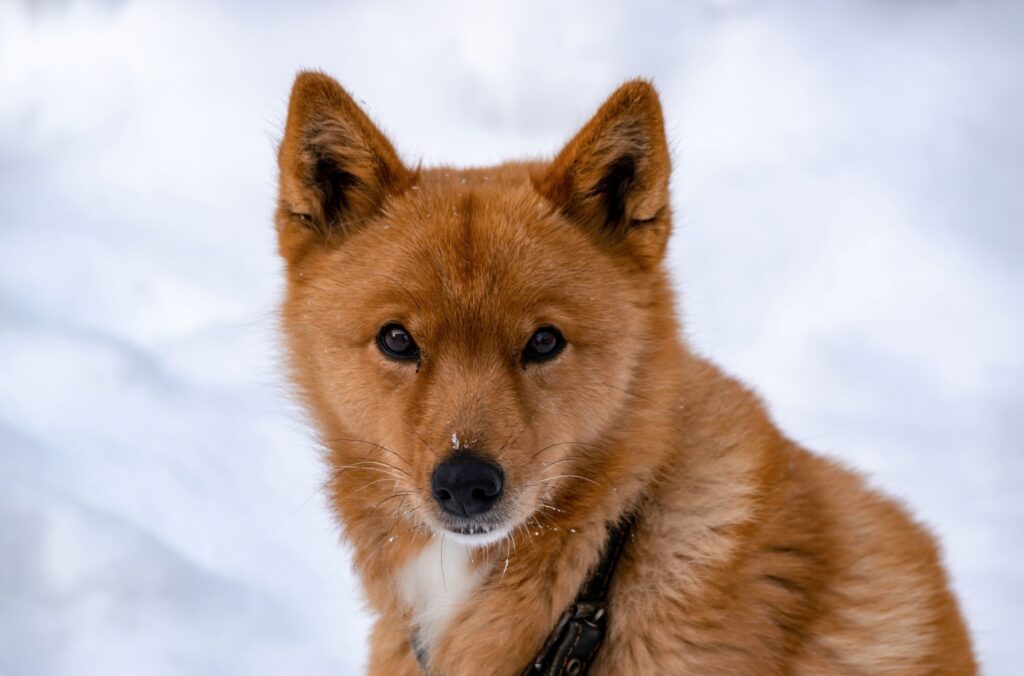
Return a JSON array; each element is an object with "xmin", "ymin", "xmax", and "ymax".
[{"xmin": 430, "ymin": 453, "xmax": 504, "ymax": 516}]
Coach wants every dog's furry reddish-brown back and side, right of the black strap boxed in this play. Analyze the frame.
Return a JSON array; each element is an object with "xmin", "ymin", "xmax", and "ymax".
[{"xmin": 600, "ymin": 360, "xmax": 974, "ymax": 675}]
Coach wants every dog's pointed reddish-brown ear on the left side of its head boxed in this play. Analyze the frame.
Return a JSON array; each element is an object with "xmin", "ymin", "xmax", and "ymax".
[{"xmin": 276, "ymin": 72, "xmax": 416, "ymax": 261}]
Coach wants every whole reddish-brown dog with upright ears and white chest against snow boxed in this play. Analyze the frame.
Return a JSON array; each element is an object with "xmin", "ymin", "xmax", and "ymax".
[{"xmin": 275, "ymin": 72, "xmax": 976, "ymax": 676}]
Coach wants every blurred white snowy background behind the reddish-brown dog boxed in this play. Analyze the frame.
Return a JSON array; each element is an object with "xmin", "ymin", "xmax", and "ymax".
[{"xmin": 0, "ymin": 0, "xmax": 1024, "ymax": 676}]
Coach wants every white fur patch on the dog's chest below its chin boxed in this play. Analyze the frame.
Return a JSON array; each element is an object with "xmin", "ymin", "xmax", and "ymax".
[{"xmin": 398, "ymin": 537, "xmax": 486, "ymax": 650}]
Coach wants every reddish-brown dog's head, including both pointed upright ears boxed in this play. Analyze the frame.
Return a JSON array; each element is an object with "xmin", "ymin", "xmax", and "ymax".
[{"xmin": 278, "ymin": 75, "xmax": 670, "ymax": 544}]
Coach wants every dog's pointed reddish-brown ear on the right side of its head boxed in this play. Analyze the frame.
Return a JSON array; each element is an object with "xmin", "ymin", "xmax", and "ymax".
[{"xmin": 534, "ymin": 80, "xmax": 672, "ymax": 267}]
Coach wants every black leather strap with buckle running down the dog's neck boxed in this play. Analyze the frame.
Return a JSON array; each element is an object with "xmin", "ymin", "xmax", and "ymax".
[{"xmin": 521, "ymin": 517, "xmax": 633, "ymax": 676}]
